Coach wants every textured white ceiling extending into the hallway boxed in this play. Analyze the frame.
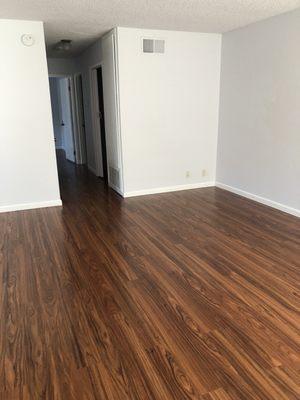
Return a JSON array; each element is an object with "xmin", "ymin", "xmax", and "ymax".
[{"xmin": 0, "ymin": 0, "xmax": 300, "ymax": 56}]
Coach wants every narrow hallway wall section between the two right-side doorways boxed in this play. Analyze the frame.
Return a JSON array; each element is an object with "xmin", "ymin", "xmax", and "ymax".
[{"xmin": 76, "ymin": 39, "xmax": 102, "ymax": 173}]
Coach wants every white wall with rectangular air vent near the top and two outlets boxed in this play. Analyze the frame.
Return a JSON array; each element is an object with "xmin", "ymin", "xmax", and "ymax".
[{"xmin": 117, "ymin": 28, "xmax": 221, "ymax": 196}]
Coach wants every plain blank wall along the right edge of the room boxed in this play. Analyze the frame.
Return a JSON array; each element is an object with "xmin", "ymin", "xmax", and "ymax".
[{"xmin": 217, "ymin": 9, "xmax": 300, "ymax": 216}]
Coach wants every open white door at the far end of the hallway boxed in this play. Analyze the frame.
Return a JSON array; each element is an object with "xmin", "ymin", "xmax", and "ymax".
[{"xmin": 59, "ymin": 78, "xmax": 75, "ymax": 162}]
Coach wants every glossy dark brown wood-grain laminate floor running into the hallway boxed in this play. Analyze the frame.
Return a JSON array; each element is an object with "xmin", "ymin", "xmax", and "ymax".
[{"xmin": 0, "ymin": 151, "xmax": 300, "ymax": 400}]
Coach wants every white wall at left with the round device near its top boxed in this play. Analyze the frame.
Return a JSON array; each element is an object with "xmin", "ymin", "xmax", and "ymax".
[{"xmin": 0, "ymin": 20, "xmax": 61, "ymax": 211}]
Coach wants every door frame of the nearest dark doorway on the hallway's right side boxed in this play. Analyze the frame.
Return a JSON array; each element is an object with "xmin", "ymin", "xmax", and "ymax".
[{"xmin": 89, "ymin": 62, "xmax": 109, "ymax": 181}]
